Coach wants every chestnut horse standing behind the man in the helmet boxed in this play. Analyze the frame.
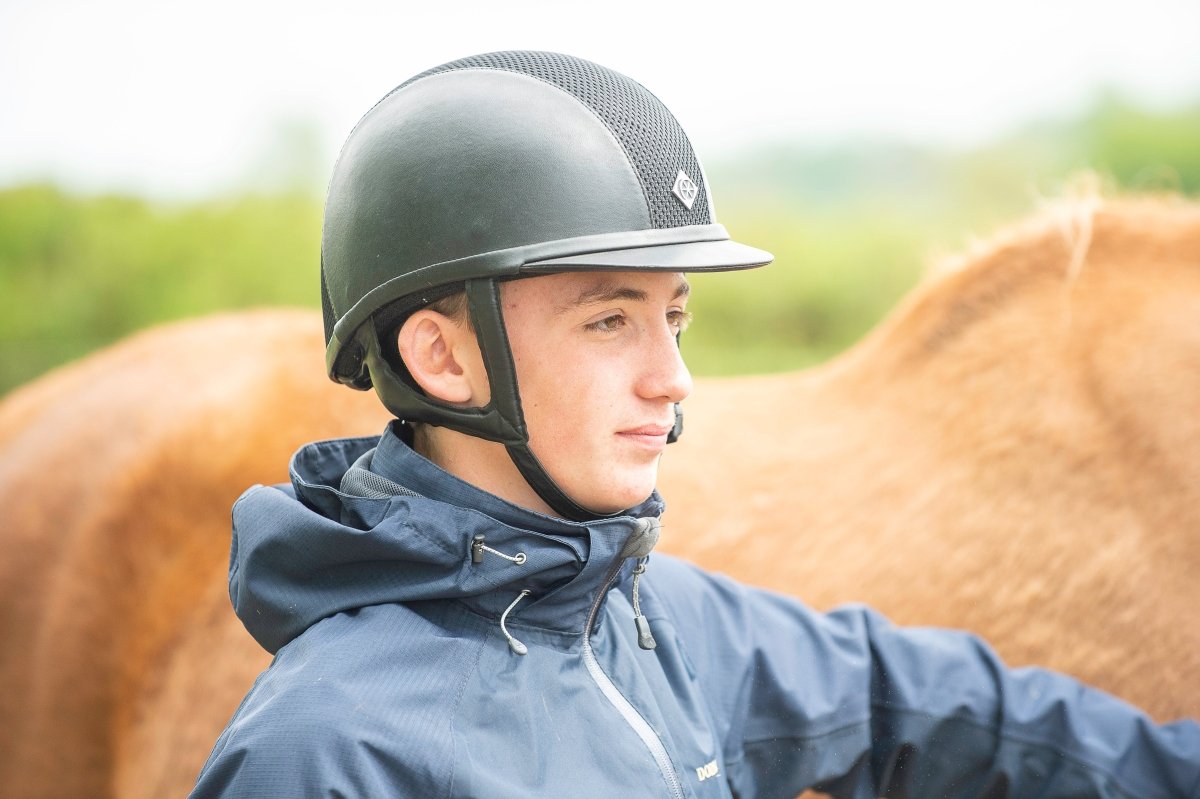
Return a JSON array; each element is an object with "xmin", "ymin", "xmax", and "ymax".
[{"xmin": 0, "ymin": 194, "xmax": 1200, "ymax": 799}]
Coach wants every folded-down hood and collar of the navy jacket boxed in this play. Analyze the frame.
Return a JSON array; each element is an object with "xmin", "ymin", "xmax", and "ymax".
[{"xmin": 229, "ymin": 422, "xmax": 662, "ymax": 654}]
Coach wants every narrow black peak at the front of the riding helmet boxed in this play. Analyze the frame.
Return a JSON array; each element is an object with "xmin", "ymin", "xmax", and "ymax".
[{"xmin": 520, "ymin": 239, "xmax": 775, "ymax": 275}]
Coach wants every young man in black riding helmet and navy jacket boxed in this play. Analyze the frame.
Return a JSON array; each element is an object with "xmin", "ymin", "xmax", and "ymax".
[{"xmin": 193, "ymin": 53, "xmax": 1200, "ymax": 799}]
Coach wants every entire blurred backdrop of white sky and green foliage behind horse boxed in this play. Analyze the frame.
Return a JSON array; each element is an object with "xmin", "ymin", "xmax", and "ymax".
[{"xmin": 0, "ymin": 0, "xmax": 1200, "ymax": 394}]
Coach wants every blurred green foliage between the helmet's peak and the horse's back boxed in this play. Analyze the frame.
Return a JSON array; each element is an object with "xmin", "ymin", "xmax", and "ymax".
[{"xmin": 684, "ymin": 95, "xmax": 1200, "ymax": 374}]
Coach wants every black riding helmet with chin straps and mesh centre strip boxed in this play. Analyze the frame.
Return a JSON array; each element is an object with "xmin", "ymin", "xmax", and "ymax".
[{"xmin": 322, "ymin": 52, "xmax": 772, "ymax": 521}]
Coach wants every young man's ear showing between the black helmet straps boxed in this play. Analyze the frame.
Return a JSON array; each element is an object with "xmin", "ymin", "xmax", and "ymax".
[{"xmin": 396, "ymin": 308, "xmax": 491, "ymax": 407}]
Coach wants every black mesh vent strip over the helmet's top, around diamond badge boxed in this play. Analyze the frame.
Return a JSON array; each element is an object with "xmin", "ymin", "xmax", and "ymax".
[{"xmin": 397, "ymin": 50, "xmax": 713, "ymax": 228}]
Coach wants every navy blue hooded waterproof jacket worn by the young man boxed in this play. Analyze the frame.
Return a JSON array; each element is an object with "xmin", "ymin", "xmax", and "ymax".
[{"xmin": 192, "ymin": 428, "xmax": 1200, "ymax": 799}]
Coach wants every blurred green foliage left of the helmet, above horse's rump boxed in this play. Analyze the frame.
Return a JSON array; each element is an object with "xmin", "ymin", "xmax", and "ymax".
[{"xmin": 0, "ymin": 186, "xmax": 320, "ymax": 391}]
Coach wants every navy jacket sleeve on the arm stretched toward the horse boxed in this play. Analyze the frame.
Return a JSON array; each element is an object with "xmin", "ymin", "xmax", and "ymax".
[{"xmin": 655, "ymin": 559, "xmax": 1200, "ymax": 799}]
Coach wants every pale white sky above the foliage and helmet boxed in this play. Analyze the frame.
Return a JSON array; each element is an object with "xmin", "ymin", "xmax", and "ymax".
[{"xmin": 0, "ymin": 0, "xmax": 1200, "ymax": 198}]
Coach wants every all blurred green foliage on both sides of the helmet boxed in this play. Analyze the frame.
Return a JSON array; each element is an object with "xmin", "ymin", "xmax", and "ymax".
[{"xmin": 0, "ymin": 96, "xmax": 1200, "ymax": 394}]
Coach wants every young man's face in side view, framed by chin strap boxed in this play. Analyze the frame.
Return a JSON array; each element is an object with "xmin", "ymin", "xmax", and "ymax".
[{"xmin": 502, "ymin": 272, "xmax": 691, "ymax": 513}]
